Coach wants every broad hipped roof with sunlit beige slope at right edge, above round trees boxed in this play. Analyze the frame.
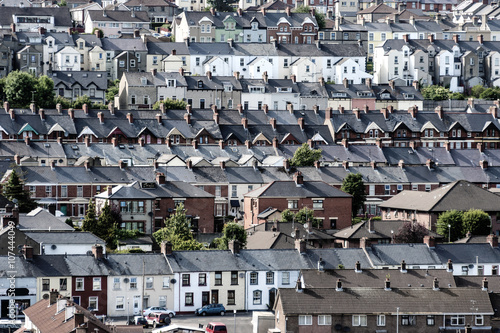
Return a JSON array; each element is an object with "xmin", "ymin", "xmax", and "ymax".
[{"xmin": 379, "ymin": 180, "xmax": 500, "ymax": 212}]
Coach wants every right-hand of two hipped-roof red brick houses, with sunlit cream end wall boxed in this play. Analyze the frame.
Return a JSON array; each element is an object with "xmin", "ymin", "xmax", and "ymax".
[{"xmin": 244, "ymin": 172, "xmax": 352, "ymax": 229}]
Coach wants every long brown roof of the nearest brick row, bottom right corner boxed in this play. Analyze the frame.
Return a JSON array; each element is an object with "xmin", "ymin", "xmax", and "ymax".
[{"xmin": 278, "ymin": 288, "xmax": 493, "ymax": 316}]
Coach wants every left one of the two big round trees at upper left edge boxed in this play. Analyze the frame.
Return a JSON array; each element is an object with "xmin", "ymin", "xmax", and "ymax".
[{"xmin": 4, "ymin": 71, "xmax": 37, "ymax": 108}]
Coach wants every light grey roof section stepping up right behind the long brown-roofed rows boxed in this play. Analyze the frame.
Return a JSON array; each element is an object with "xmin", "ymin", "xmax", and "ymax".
[{"xmin": 366, "ymin": 244, "xmax": 443, "ymax": 266}]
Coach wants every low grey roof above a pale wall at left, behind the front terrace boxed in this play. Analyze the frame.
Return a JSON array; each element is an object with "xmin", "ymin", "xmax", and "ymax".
[{"xmin": 24, "ymin": 231, "xmax": 106, "ymax": 245}]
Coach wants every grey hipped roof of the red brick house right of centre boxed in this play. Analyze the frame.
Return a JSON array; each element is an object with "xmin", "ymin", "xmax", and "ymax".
[{"xmin": 245, "ymin": 181, "xmax": 351, "ymax": 198}]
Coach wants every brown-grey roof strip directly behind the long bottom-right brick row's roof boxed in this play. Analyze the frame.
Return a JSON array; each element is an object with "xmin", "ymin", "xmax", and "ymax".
[{"xmin": 301, "ymin": 269, "xmax": 456, "ymax": 288}]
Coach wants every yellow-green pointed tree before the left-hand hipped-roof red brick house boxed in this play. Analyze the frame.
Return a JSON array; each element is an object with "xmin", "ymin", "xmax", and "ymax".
[{"xmin": 153, "ymin": 204, "xmax": 203, "ymax": 251}]
